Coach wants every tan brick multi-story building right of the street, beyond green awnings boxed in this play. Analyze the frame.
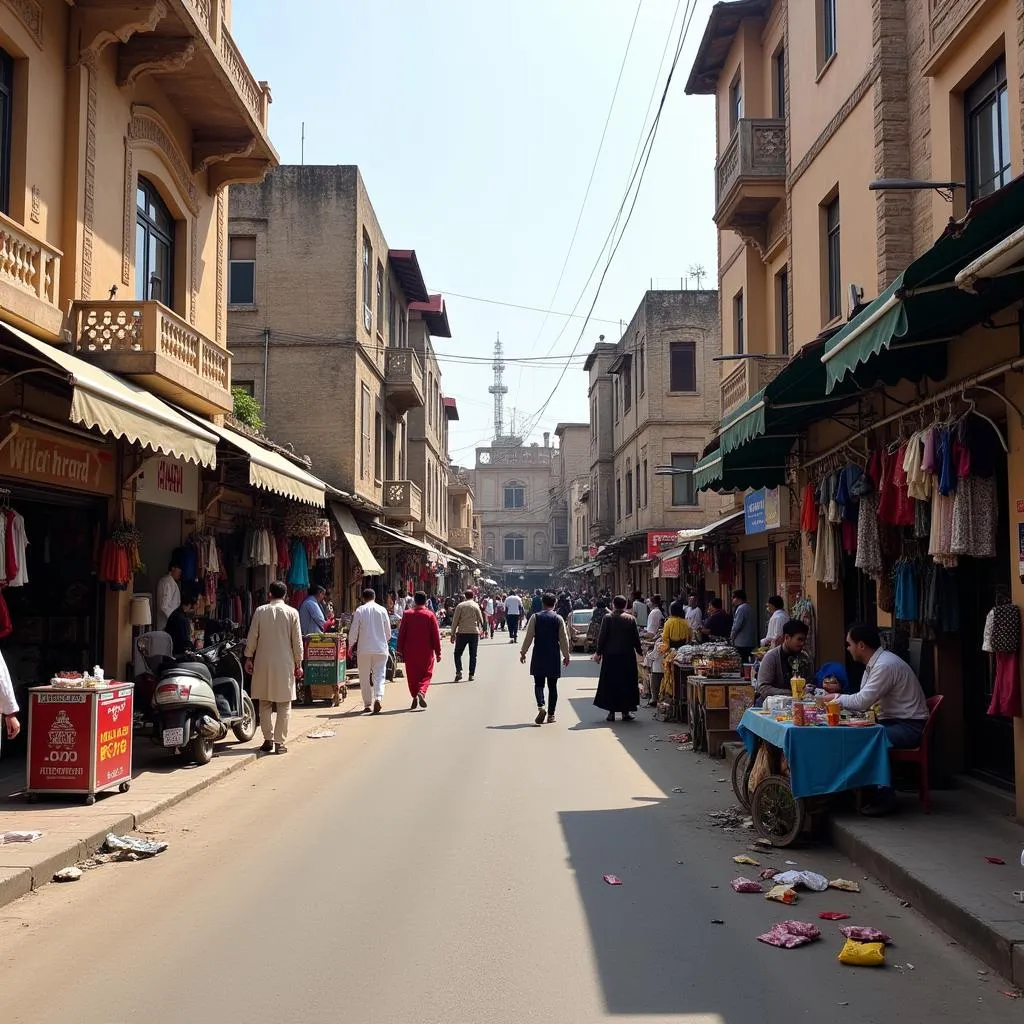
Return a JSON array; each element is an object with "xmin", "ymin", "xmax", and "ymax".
[{"xmin": 588, "ymin": 291, "xmax": 722, "ymax": 593}]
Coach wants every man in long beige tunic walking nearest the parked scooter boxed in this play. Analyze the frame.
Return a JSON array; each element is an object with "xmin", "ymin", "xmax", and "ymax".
[{"xmin": 246, "ymin": 580, "xmax": 302, "ymax": 754}]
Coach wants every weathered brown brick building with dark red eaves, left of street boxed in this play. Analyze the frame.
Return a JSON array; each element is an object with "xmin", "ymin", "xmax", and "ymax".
[{"xmin": 228, "ymin": 166, "xmax": 468, "ymax": 590}]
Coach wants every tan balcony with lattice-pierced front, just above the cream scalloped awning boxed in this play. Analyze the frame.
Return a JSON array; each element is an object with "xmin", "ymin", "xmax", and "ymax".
[{"xmin": 71, "ymin": 301, "xmax": 231, "ymax": 415}]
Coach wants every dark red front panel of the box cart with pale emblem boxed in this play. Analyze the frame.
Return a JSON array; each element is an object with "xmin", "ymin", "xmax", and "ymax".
[{"xmin": 28, "ymin": 692, "xmax": 91, "ymax": 793}]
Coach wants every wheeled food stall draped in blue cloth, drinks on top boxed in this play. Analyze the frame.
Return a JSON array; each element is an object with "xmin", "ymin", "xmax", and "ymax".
[{"xmin": 733, "ymin": 697, "xmax": 892, "ymax": 846}]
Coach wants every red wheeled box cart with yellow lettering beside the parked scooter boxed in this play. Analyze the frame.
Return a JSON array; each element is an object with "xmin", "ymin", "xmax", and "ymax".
[{"xmin": 25, "ymin": 681, "xmax": 133, "ymax": 804}]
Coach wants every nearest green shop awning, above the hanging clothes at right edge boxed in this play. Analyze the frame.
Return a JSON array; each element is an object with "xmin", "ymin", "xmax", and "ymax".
[{"xmin": 821, "ymin": 177, "xmax": 1024, "ymax": 392}]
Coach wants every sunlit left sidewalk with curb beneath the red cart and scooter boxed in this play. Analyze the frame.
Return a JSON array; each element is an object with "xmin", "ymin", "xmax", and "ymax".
[{"xmin": 0, "ymin": 691, "xmax": 348, "ymax": 906}]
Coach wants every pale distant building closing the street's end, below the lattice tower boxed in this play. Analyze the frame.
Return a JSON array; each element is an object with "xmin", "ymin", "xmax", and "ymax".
[{"xmin": 472, "ymin": 436, "xmax": 558, "ymax": 589}]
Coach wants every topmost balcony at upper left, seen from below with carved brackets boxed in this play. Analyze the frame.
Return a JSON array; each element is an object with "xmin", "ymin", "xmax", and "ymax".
[{"xmin": 75, "ymin": 0, "xmax": 279, "ymax": 195}]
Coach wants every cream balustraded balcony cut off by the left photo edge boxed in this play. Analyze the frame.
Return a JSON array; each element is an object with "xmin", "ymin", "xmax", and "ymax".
[{"xmin": 0, "ymin": 213, "xmax": 63, "ymax": 341}]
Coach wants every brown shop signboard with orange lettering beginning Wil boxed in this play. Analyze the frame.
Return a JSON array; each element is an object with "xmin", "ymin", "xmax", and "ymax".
[{"xmin": 0, "ymin": 423, "xmax": 116, "ymax": 495}]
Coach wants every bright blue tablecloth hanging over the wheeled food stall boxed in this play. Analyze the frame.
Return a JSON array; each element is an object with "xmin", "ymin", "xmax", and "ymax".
[{"xmin": 737, "ymin": 710, "xmax": 892, "ymax": 797}]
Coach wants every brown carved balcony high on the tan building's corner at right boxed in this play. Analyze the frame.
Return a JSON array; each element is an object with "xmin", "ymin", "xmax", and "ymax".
[{"xmin": 715, "ymin": 118, "xmax": 786, "ymax": 253}]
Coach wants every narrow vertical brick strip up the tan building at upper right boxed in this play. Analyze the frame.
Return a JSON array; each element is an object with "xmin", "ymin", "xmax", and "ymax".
[{"xmin": 871, "ymin": 0, "xmax": 913, "ymax": 292}]
